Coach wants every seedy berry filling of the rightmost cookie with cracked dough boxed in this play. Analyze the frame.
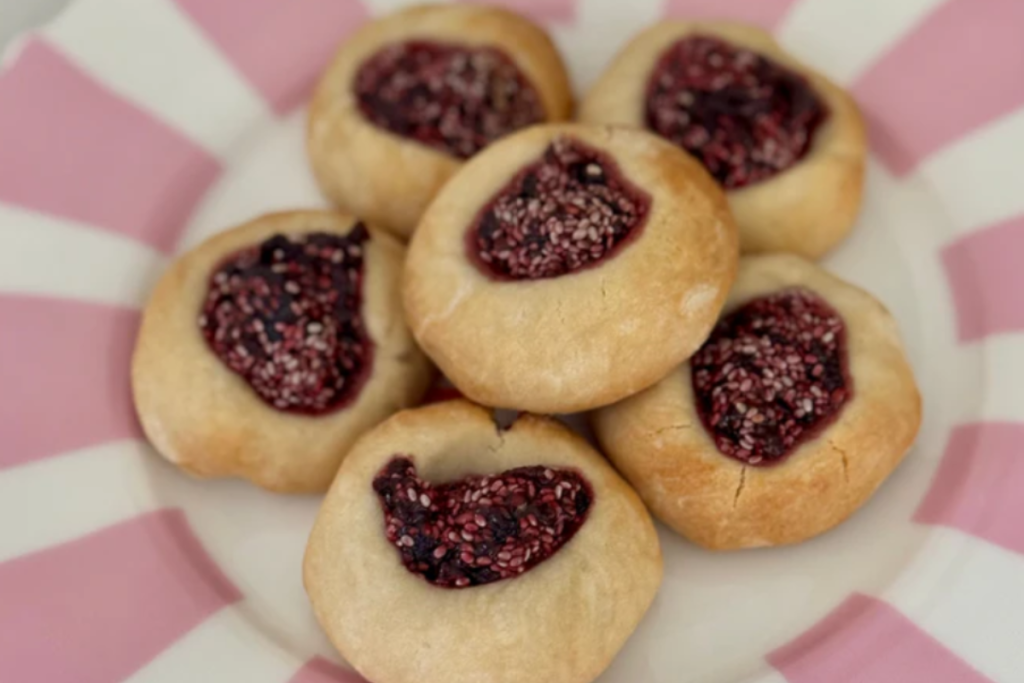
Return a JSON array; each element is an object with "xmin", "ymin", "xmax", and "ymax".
[{"xmin": 690, "ymin": 289, "xmax": 853, "ymax": 465}]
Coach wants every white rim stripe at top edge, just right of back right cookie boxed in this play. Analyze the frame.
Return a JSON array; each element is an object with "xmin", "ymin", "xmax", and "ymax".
[{"xmin": 778, "ymin": 0, "xmax": 942, "ymax": 83}]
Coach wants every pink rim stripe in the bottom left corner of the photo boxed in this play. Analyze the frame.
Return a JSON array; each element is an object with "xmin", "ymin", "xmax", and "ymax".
[{"xmin": 0, "ymin": 510, "xmax": 242, "ymax": 683}]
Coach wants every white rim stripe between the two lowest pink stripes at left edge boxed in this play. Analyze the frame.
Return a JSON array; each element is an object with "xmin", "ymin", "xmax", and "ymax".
[{"xmin": 0, "ymin": 441, "xmax": 158, "ymax": 562}]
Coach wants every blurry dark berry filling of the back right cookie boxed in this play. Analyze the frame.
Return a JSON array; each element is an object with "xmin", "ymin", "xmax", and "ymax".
[{"xmin": 646, "ymin": 36, "xmax": 828, "ymax": 189}]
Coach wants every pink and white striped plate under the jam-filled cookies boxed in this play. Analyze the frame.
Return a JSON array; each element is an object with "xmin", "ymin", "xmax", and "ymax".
[{"xmin": 0, "ymin": 0, "xmax": 1024, "ymax": 683}]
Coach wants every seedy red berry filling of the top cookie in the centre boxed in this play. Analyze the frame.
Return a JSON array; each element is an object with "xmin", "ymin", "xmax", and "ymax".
[{"xmin": 467, "ymin": 137, "xmax": 650, "ymax": 280}]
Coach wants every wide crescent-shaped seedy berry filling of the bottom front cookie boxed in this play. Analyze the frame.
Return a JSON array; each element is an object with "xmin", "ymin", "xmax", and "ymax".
[{"xmin": 374, "ymin": 456, "xmax": 594, "ymax": 588}]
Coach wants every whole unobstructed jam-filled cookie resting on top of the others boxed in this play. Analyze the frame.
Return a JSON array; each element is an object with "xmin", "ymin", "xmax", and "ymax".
[{"xmin": 403, "ymin": 124, "xmax": 738, "ymax": 413}]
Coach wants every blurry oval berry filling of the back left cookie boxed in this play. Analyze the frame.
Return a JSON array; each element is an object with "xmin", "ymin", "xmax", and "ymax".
[{"xmin": 354, "ymin": 40, "xmax": 544, "ymax": 159}]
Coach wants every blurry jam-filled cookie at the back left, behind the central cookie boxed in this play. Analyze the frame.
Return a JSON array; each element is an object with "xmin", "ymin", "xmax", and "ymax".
[{"xmin": 306, "ymin": 4, "xmax": 572, "ymax": 238}]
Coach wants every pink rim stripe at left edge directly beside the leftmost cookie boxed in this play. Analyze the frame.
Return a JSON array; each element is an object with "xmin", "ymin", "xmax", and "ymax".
[{"xmin": 0, "ymin": 296, "xmax": 141, "ymax": 466}]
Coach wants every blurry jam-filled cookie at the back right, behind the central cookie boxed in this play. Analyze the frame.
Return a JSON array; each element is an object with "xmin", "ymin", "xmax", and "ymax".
[{"xmin": 580, "ymin": 22, "xmax": 866, "ymax": 258}]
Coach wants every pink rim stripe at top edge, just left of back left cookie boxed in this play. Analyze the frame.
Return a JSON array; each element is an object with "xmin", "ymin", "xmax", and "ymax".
[{"xmin": 176, "ymin": 0, "xmax": 368, "ymax": 114}]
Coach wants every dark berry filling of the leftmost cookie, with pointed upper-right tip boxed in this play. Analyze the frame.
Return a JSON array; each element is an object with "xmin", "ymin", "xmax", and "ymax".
[{"xmin": 199, "ymin": 223, "xmax": 373, "ymax": 415}]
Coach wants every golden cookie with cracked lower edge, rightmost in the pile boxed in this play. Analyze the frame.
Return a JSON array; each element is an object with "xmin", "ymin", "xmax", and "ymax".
[{"xmin": 593, "ymin": 254, "xmax": 921, "ymax": 549}]
